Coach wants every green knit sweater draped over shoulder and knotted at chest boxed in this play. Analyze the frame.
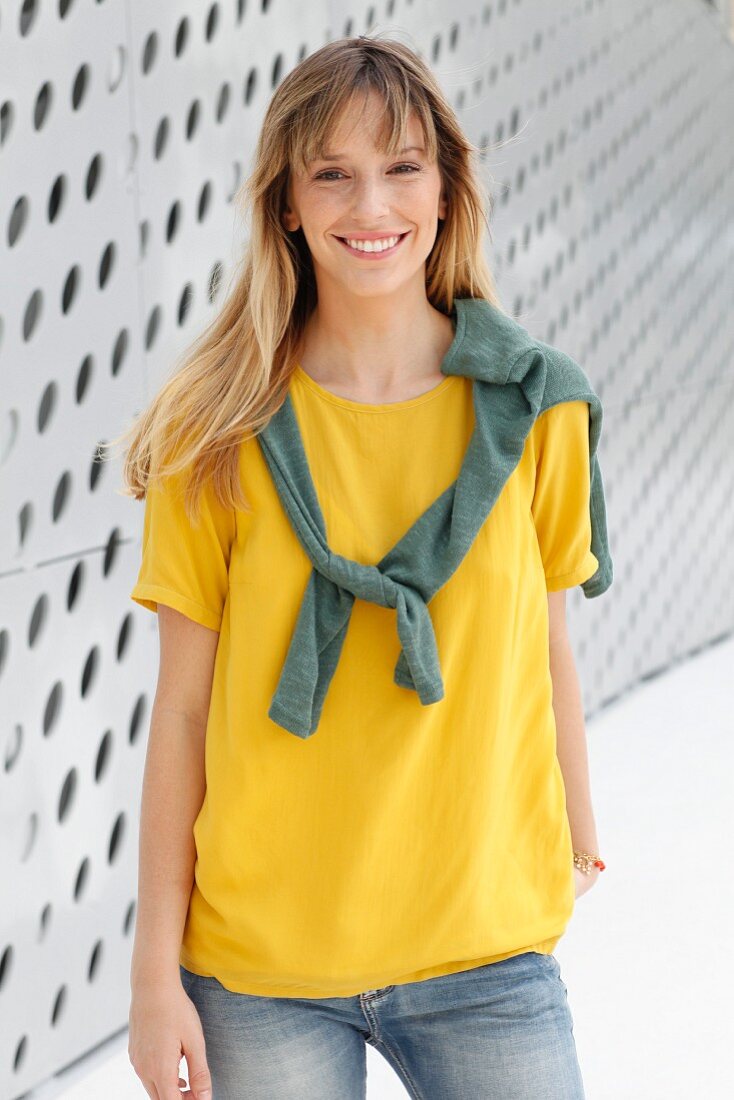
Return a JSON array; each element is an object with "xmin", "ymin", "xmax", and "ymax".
[{"xmin": 258, "ymin": 298, "xmax": 613, "ymax": 738}]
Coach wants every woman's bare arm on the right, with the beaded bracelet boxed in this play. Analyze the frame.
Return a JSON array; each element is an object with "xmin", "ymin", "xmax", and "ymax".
[{"xmin": 548, "ymin": 589, "xmax": 600, "ymax": 884}]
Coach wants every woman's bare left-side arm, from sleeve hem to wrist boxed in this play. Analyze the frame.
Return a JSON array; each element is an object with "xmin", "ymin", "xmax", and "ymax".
[{"xmin": 130, "ymin": 604, "xmax": 219, "ymax": 988}]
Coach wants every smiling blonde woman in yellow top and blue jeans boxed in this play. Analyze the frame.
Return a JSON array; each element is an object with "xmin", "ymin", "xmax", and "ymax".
[{"xmin": 120, "ymin": 30, "xmax": 612, "ymax": 1100}]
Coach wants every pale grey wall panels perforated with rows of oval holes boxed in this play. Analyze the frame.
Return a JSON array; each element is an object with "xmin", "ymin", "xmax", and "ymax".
[{"xmin": 0, "ymin": 0, "xmax": 734, "ymax": 1098}]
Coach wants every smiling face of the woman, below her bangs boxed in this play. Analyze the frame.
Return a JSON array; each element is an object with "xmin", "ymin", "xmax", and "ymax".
[{"xmin": 283, "ymin": 92, "xmax": 447, "ymax": 297}]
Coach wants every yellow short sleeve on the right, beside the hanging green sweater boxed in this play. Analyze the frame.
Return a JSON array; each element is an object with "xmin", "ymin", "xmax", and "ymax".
[{"xmin": 532, "ymin": 400, "xmax": 599, "ymax": 592}]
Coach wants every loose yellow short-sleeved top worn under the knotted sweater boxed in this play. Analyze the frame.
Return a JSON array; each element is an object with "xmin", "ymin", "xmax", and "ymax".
[{"xmin": 131, "ymin": 366, "xmax": 598, "ymax": 998}]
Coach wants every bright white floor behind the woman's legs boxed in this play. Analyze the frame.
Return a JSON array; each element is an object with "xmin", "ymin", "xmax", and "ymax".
[{"xmin": 50, "ymin": 639, "xmax": 734, "ymax": 1100}]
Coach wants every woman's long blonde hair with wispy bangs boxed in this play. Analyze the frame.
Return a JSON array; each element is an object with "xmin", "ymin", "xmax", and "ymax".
[{"xmin": 107, "ymin": 35, "xmax": 503, "ymax": 519}]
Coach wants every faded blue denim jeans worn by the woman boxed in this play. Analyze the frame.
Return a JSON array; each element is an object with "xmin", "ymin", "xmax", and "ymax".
[{"xmin": 180, "ymin": 952, "xmax": 584, "ymax": 1100}]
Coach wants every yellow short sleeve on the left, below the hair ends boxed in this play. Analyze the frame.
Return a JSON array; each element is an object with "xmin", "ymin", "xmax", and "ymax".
[{"xmin": 130, "ymin": 464, "xmax": 235, "ymax": 630}]
